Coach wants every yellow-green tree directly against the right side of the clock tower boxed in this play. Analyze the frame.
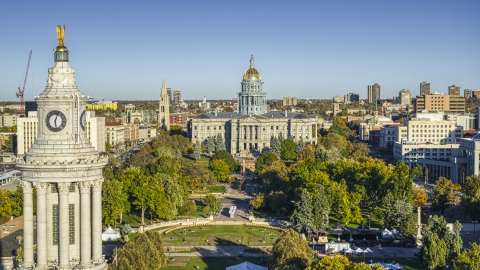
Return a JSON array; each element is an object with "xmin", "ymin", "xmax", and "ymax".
[{"xmin": 102, "ymin": 179, "xmax": 130, "ymax": 224}]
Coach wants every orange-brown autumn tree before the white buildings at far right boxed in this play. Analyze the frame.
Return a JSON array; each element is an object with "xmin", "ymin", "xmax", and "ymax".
[{"xmin": 432, "ymin": 176, "xmax": 460, "ymax": 215}]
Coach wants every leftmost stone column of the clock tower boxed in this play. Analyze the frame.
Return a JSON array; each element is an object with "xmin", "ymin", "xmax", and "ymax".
[{"xmin": 22, "ymin": 181, "xmax": 35, "ymax": 268}]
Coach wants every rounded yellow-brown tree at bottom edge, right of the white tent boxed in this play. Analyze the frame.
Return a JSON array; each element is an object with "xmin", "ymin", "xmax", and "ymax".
[{"xmin": 270, "ymin": 229, "xmax": 312, "ymax": 270}]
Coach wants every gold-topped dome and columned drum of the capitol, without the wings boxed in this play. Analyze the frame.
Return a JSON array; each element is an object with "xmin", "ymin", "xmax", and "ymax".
[{"xmin": 237, "ymin": 55, "xmax": 267, "ymax": 114}]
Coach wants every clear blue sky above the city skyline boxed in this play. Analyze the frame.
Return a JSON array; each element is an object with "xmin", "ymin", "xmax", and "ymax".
[{"xmin": 0, "ymin": 0, "xmax": 480, "ymax": 100}]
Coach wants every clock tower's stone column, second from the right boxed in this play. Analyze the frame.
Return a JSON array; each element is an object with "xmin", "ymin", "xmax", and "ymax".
[{"xmin": 78, "ymin": 181, "xmax": 92, "ymax": 267}]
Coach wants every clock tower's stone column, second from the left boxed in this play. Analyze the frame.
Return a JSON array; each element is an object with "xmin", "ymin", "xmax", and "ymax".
[{"xmin": 36, "ymin": 183, "xmax": 50, "ymax": 269}]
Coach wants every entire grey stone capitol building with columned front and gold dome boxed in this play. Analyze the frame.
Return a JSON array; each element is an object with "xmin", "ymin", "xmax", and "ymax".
[{"xmin": 187, "ymin": 56, "xmax": 318, "ymax": 156}]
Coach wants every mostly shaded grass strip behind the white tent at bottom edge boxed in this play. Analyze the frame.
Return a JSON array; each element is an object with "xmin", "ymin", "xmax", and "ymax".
[{"xmin": 162, "ymin": 257, "xmax": 269, "ymax": 270}]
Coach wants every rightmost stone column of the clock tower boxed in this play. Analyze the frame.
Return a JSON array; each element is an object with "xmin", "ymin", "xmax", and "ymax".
[{"xmin": 92, "ymin": 179, "xmax": 103, "ymax": 262}]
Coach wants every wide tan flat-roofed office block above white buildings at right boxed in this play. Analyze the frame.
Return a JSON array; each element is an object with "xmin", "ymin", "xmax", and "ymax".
[{"xmin": 415, "ymin": 93, "xmax": 465, "ymax": 113}]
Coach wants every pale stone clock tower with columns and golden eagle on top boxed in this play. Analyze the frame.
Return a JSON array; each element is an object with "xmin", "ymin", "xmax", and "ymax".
[{"xmin": 17, "ymin": 26, "xmax": 107, "ymax": 269}]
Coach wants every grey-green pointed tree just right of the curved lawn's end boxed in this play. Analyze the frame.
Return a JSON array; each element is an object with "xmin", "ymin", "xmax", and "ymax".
[{"xmin": 290, "ymin": 189, "xmax": 314, "ymax": 233}]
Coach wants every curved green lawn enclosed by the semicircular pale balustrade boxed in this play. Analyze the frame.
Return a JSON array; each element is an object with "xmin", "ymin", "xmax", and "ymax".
[{"xmin": 163, "ymin": 225, "xmax": 281, "ymax": 246}]
